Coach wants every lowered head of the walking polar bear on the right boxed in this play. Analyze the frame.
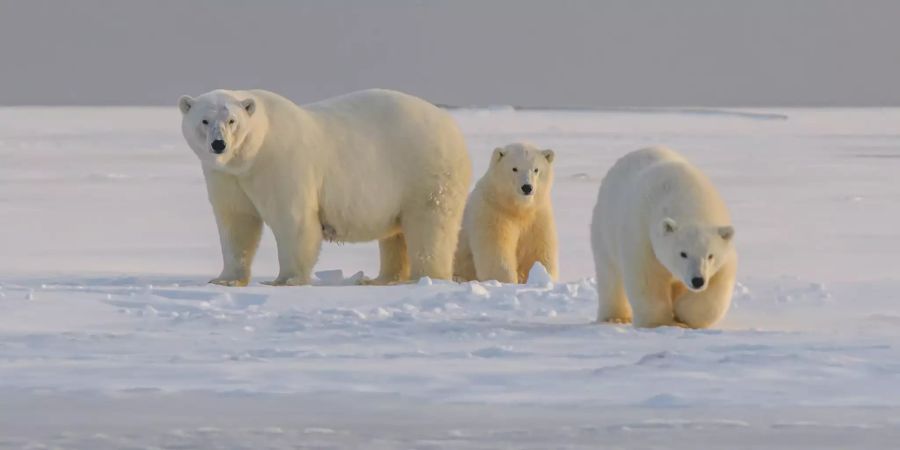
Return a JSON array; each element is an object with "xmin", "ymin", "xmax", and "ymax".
[{"xmin": 651, "ymin": 217, "xmax": 734, "ymax": 292}]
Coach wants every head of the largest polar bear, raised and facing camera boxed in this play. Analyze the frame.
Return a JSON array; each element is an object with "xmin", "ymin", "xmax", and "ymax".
[{"xmin": 178, "ymin": 90, "xmax": 265, "ymax": 174}]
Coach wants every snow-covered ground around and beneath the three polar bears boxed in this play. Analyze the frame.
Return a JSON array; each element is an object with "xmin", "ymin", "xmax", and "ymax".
[{"xmin": 0, "ymin": 107, "xmax": 900, "ymax": 449}]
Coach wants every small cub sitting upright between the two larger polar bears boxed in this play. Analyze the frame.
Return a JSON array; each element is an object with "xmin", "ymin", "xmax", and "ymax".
[{"xmin": 453, "ymin": 143, "xmax": 558, "ymax": 283}]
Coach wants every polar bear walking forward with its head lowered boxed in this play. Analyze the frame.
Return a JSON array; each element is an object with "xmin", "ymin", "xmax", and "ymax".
[{"xmin": 591, "ymin": 147, "xmax": 737, "ymax": 328}]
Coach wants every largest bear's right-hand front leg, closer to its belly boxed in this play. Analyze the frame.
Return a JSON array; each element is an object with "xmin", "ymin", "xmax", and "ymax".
[{"xmin": 263, "ymin": 214, "xmax": 322, "ymax": 286}]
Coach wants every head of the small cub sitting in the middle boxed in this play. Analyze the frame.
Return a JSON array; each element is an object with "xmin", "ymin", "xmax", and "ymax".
[{"xmin": 488, "ymin": 143, "xmax": 555, "ymax": 204}]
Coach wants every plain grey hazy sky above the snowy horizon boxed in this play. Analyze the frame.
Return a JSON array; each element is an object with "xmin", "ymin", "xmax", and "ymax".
[{"xmin": 0, "ymin": 0, "xmax": 900, "ymax": 106}]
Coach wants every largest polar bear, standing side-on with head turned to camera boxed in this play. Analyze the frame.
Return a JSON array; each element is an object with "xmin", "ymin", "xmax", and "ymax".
[{"xmin": 178, "ymin": 89, "xmax": 472, "ymax": 286}]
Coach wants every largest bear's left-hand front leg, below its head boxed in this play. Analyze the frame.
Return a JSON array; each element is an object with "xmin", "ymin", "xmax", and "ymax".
[{"xmin": 204, "ymin": 170, "xmax": 263, "ymax": 286}]
